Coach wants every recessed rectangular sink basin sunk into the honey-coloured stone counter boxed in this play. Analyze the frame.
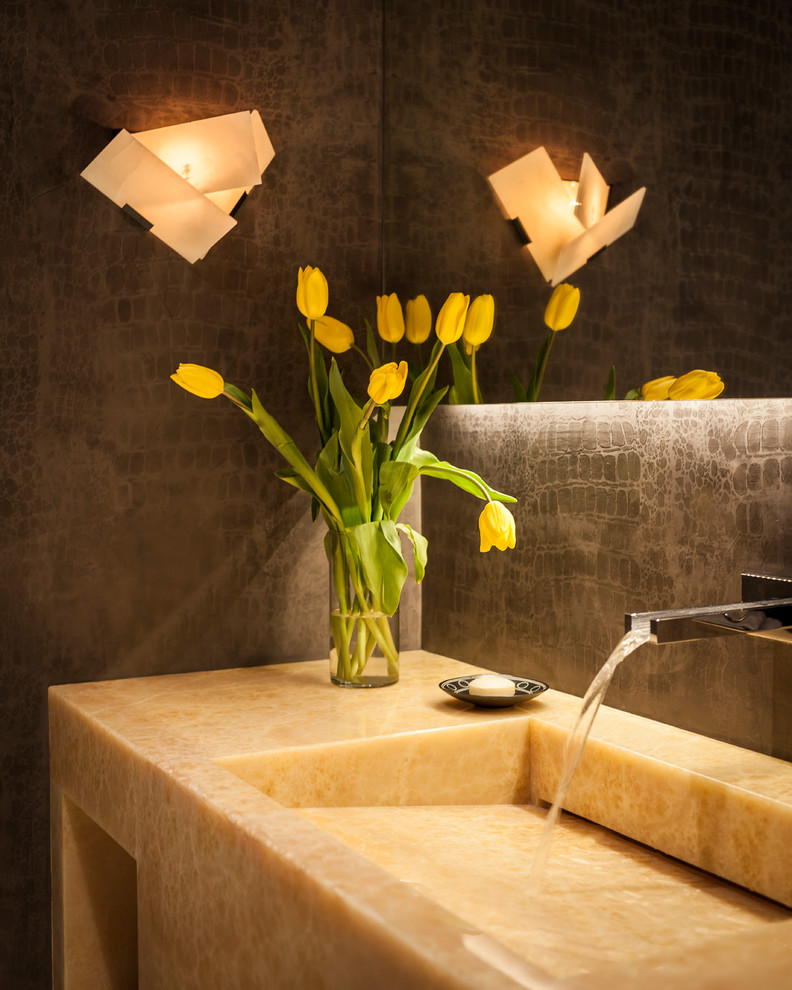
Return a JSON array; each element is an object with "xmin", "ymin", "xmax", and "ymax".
[{"xmin": 218, "ymin": 702, "xmax": 792, "ymax": 985}]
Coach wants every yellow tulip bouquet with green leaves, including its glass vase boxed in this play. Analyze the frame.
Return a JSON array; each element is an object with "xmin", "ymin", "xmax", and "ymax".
[{"xmin": 171, "ymin": 267, "xmax": 515, "ymax": 686}]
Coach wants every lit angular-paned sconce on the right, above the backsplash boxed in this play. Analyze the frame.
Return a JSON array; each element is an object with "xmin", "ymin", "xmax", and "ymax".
[{"xmin": 489, "ymin": 148, "xmax": 646, "ymax": 285}]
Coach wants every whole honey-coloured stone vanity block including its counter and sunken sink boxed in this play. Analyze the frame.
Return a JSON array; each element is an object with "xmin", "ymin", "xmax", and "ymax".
[{"xmin": 51, "ymin": 652, "xmax": 792, "ymax": 990}]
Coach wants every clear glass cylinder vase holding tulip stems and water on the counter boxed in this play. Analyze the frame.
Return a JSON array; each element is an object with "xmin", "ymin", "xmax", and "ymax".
[{"xmin": 328, "ymin": 534, "xmax": 399, "ymax": 687}]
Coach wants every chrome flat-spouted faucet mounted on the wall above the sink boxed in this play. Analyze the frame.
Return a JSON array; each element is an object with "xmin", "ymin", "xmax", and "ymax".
[{"xmin": 624, "ymin": 574, "xmax": 792, "ymax": 645}]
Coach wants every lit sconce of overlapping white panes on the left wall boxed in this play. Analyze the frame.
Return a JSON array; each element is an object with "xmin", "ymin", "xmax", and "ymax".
[{"xmin": 80, "ymin": 110, "xmax": 275, "ymax": 263}]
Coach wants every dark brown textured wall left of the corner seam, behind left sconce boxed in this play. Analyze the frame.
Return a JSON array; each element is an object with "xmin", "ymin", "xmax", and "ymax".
[{"xmin": 0, "ymin": 0, "xmax": 382, "ymax": 988}]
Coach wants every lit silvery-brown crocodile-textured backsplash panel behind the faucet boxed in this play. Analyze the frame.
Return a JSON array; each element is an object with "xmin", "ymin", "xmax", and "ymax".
[{"xmin": 423, "ymin": 399, "xmax": 792, "ymax": 759}]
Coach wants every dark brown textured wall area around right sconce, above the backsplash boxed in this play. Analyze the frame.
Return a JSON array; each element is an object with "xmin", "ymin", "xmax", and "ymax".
[{"xmin": 385, "ymin": 0, "xmax": 792, "ymax": 402}]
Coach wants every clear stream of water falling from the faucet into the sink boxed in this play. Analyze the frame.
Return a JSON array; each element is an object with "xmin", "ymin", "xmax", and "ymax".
[{"xmin": 529, "ymin": 626, "xmax": 650, "ymax": 890}]
